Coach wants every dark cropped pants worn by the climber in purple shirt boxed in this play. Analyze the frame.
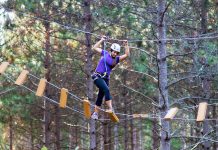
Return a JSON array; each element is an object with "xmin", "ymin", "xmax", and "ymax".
[{"xmin": 94, "ymin": 78, "xmax": 111, "ymax": 106}]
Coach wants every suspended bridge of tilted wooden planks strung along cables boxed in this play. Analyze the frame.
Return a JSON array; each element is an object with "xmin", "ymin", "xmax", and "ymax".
[{"xmin": 0, "ymin": 62, "xmax": 216, "ymax": 122}]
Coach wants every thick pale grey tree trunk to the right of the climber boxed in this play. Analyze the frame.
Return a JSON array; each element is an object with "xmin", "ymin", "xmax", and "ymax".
[{"xmin": 157, "ymin": 0, "xmax": 170, "ymax": 150}]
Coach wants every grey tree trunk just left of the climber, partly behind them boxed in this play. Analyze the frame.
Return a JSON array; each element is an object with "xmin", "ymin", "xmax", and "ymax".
[{"xmin": 83, "ymin": 0, "xmax": 96, "ymax": 150}]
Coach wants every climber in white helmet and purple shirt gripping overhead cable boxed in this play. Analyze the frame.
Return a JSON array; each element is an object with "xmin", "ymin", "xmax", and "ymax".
[{"xmin": 91, "ymin": 36, "xmax": 129, "ymax": 120}]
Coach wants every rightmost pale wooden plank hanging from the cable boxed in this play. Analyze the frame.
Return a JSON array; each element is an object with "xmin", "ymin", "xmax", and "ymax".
[{"xmin": 196, "ymin": 102, "xmax": 207, "ymax": 122}]
